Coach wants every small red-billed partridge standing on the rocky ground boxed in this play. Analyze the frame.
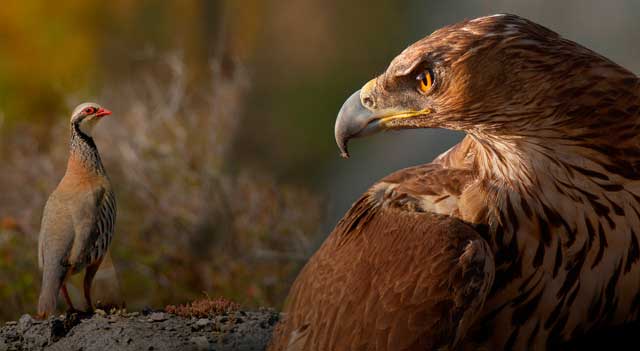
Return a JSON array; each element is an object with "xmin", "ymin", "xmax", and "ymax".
[{"xmin": 38, "ymin": 103, "xmax": 116, "ymax": 318}]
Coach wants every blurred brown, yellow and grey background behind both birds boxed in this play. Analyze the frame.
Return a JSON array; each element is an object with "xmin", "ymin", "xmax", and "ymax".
[{"xmin": 0, "ymin": 0, "xmax": 640, "ymax": 320}]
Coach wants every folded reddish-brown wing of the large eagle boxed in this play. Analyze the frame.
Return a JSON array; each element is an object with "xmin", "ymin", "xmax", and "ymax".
[{"xmin": 272, "ymin": 165, "xmax": 494, "ymax": 350}]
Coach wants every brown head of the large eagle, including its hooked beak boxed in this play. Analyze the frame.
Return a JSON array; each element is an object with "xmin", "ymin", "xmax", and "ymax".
[{"xmin": 335, "ymin": 15, "xmax": 639, "ymax": 157}]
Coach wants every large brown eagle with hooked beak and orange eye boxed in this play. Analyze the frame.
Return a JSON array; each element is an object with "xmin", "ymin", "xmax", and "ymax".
[{"xmin": 270, "ymin": 14, "xmax": 640, "ymax": 350}]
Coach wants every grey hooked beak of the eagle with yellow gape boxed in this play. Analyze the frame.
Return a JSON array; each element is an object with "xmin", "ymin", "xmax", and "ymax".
[{"xmin": 334, "ymin": 79, "xmax": 430, "ymax": 158}]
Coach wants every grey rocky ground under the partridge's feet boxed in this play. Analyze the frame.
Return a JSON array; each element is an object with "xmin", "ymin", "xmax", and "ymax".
[{"xmin": 0, "ymin": 309, "xmax": 278, "ymax": 351}]
